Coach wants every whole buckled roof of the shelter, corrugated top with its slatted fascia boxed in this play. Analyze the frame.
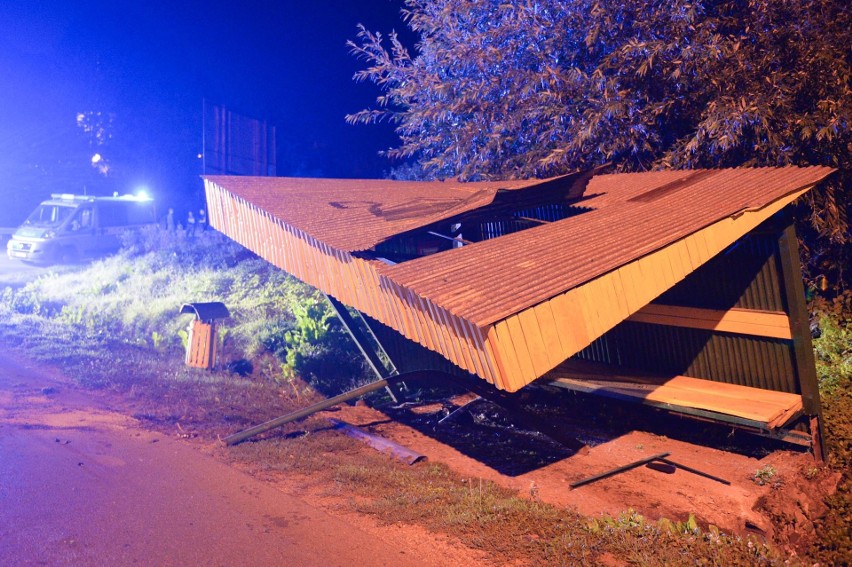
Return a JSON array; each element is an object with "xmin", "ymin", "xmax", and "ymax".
[{"xmin": 205, "ymin": 167, "xmax": 833, "ymax": 391}]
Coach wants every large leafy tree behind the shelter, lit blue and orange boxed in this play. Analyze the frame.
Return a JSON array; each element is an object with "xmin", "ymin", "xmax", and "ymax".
[{"xmin": 347, "ymin": 0, "xmax": 852, "ymax": 248}]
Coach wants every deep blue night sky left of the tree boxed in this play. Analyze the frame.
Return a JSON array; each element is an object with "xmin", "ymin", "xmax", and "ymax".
[{"xmin": 0, "ymin": 0, "xmax": 414, "ymax": 227}]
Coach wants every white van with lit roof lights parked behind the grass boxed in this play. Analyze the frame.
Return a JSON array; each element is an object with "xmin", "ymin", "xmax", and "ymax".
[{"xmin": 6, "ymin": 194, "xmax": 157, "ymax": 263}]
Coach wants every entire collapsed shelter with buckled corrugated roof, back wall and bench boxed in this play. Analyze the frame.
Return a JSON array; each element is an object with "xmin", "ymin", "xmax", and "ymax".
[{"xmin": 205, "ymin": 167, "xmax": 833, "ymax": 457}]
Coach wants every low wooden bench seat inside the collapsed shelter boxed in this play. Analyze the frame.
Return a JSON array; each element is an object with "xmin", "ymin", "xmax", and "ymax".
[{"xmin": 541, "ymin": 359, "xmax": 802, "ymax": 432}]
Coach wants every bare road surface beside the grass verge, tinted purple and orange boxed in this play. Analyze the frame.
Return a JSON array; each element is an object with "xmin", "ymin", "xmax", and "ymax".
[{"xmin": 0, "ymin": 354, "xmax": 472, "ymax": 566}]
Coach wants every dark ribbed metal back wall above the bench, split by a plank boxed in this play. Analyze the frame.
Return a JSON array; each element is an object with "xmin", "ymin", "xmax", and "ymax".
[{"xmin": 577, "ymin": 225, "xmax": 801, "ymax": 394}]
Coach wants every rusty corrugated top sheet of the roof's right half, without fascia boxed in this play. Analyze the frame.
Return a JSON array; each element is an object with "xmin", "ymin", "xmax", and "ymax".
[{"xmin": 382, "ymin": 167, "xmax": 833, "ymax": 326}]
